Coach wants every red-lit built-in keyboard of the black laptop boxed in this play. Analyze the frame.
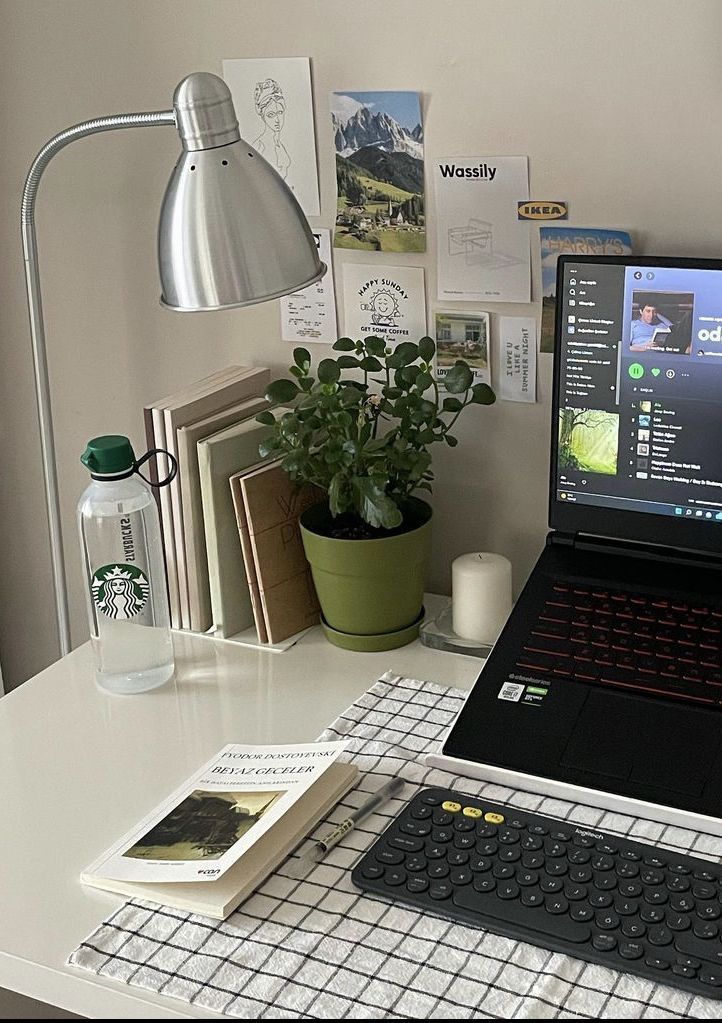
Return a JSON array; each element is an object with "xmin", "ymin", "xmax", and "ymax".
[{"xmin": 516, "ymin": 582, "xmax": 722, "ymax": 707}]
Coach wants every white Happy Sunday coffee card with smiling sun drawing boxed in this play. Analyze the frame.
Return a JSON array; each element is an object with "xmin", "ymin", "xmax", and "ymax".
[{"xmin": 344, "ymin": 263, "xmax": 426, "ymax": 345}]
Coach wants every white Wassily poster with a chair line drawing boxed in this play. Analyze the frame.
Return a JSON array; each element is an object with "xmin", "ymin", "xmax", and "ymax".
[{"xmin": 432, "ymin": 157, "xmax": 532, "ymax": 303}]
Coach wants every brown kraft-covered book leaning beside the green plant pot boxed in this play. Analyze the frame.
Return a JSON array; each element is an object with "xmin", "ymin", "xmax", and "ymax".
[{"xmin": 230, "ymin": 461, "xmax": 323, "ymax": 642}]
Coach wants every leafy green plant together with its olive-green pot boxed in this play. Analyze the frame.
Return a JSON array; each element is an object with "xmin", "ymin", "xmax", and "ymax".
[{"xmin": 257, "ymin": 338, "xmax": 495, "ymax": 651}]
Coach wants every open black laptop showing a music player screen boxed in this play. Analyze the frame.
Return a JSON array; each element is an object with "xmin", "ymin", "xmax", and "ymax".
[{"xmin": 428, "ymin": 256, "xmax": 722, "ymax": 836}]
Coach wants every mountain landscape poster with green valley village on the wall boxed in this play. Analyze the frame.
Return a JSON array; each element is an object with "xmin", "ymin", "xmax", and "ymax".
[{"xmin": 331, "ymin": 92, "xmax": 426, "ymax": 253}]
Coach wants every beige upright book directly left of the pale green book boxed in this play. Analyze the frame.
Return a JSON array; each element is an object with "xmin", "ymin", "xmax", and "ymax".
[{"xmin": 176, "ymin": 390, "xmax": 268, "ymax": 632}]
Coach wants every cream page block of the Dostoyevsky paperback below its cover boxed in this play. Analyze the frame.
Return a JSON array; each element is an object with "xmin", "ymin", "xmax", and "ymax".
[{"xmin": 81, "ymin": 762, "xmax": 358, "ymax": 920}]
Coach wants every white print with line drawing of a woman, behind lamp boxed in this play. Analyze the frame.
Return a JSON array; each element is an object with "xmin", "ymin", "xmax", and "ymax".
[{"xmin": 223, "ymin": 57, "xmax": 321, "ymax": 217}]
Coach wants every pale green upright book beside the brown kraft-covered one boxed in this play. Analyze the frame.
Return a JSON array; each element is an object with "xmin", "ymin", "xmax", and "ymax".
[{"xmin": 197, "ymin": 407, "xmax": 287, "ymax": 637}]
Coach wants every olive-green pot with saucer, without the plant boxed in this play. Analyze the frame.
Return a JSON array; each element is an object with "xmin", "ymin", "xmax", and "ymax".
[{"xmin": 301, "ymin": 497, "xmax": 432, "ymax": 651}]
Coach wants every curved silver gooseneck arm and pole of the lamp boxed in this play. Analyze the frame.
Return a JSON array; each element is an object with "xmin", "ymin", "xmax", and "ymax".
[{"xmin": 20, "ymin": 110, "xmax": 176, "ymax": 657}]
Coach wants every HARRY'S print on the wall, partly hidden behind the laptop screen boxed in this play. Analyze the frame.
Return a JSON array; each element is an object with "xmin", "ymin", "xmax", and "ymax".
[{"xmin": 539, "ymin": 226, "xmax": 632, "ymax": 352}]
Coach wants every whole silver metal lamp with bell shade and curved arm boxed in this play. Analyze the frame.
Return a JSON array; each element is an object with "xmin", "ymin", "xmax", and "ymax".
[{"xmin": 21, "ymin": 72, "xmax": 326, "ymax": 655}]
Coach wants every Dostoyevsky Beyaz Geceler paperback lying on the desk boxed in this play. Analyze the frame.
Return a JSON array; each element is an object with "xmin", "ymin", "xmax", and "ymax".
[{"xmin": 81, "ymin": 742, "xmax": 358, "ymax": 920}]
